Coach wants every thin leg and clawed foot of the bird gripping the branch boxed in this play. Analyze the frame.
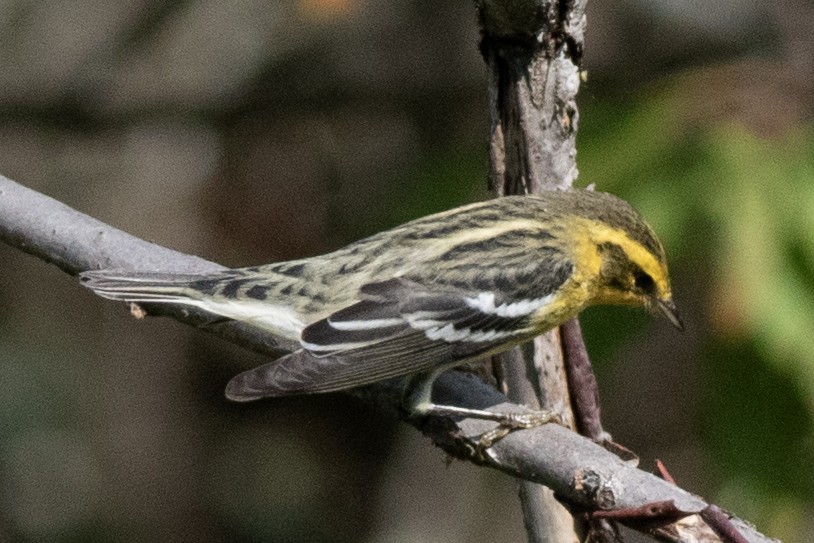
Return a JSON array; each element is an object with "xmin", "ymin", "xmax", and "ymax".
[{"xmin": 402, "ymin": 374, "xmax": 562, "ymax": 448}]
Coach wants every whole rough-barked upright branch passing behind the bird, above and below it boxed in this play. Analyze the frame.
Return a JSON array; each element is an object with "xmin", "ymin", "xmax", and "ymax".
[{"xmin": 477, "ymin": 0, "xmax": 586, "ymax": 543}]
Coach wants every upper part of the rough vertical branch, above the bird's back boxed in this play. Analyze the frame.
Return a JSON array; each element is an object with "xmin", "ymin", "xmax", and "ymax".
[{"xmin": 479, "ymin": 0, "xmax": 586, "ymax": 195}]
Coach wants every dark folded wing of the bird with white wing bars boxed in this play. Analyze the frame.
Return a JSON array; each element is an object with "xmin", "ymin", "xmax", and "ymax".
[{"xmin": 227, "ymin": 279, "xmax": 568, "ymax": 401}]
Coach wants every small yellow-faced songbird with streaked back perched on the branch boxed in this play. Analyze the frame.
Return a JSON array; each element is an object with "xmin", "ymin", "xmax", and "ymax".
[{"xmin": 81, "ymin": 190, "xmax": 682, "ymax": 420}]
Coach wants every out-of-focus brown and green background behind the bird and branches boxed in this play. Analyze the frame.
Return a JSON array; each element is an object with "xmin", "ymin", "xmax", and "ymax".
[{"xmin": 0, "ymin": 0, "xmax": 814, "ymax": 542}]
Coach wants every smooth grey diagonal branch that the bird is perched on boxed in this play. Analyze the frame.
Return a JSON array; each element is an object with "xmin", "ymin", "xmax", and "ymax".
[{"xmin": 0, "ymin": 176, "xmax": 770, "ymax": 543}]
